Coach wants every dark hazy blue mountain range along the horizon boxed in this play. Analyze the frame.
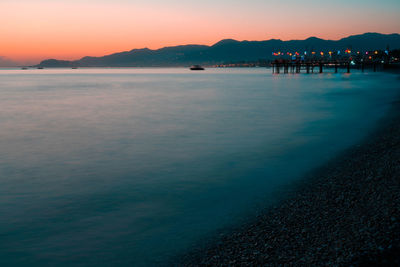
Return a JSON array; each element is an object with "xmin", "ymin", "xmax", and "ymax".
[{"xmin": 38, "ymin": 33, "xmax": 400, "ymax": 67}]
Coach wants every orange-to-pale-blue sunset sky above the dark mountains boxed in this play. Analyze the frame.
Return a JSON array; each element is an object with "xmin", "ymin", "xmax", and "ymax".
[{"xmin": 0, "ymin": 0, "xmax": 400, "ymax": 66}]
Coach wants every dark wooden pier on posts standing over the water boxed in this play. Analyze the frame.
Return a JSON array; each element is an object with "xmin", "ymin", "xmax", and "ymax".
[{"xmin": 271, "ymin": 61, "xmax": 383, "ymax": 74}]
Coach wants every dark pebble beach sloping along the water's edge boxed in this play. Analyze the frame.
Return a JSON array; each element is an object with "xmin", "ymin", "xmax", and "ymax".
[{"xmin": 177, "ymin": 75, "xmax": 400, "ymax": 266}]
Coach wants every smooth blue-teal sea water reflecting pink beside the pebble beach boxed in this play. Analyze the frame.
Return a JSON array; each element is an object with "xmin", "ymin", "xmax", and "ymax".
[{"xmin": 0, "ymin": 69, "xmax": 398, "ymax": 266}]
